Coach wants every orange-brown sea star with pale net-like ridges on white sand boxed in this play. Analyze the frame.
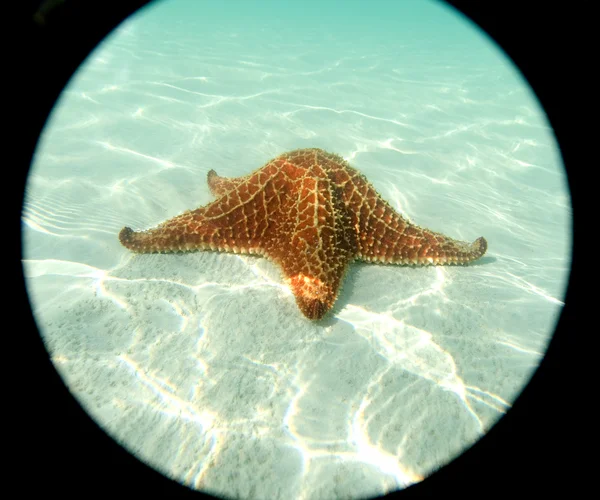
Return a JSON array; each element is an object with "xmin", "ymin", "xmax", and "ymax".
[{"xmin": 119, "ymin": 148, "xmax": 487, "ymax": 320}]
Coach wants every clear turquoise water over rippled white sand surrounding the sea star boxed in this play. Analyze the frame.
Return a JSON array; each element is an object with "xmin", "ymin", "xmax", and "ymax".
[{"xmin": 23, "ymin": 0, "xmax": 571, "ymax": 499}]
